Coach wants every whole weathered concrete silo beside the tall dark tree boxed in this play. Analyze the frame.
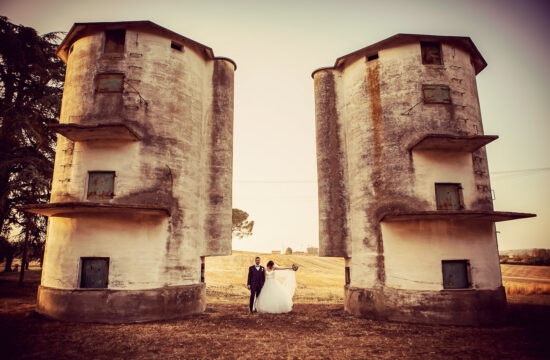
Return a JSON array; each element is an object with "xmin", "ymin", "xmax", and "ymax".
[{"xmin": 18, "ymin": 21, "xmax": 236, "ymax": 322}]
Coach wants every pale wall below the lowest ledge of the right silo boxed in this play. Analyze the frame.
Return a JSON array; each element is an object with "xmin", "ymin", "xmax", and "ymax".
[{"xmin": 381, "ymin": 221, "xmax": 502, "ymax": 291}]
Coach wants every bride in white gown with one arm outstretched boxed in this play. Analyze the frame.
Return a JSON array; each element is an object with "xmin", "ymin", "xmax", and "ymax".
[{"xmin": 255, "ymin": 260, "xmax": 297, "ymax": 314}]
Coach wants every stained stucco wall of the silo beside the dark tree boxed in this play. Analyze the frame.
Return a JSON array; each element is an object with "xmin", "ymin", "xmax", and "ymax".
[{"xmin": 42, "ymin": 26, "xmax": 234, "ymax": 324}]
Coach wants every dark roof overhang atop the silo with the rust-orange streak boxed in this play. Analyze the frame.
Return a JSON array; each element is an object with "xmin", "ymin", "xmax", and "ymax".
[{"xmin": 311, "ymin": 34, "xmax": 487, "ymax": 77}]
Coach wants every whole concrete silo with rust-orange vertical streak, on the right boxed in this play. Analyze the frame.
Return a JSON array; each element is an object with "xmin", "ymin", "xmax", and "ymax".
[{"xmin": 312, "ymin": 34, "xmax": 534, "ymax": 324}]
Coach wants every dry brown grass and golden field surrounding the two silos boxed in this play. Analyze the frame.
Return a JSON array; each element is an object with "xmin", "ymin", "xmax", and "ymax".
[{"xmin": 0, "ymin": 252, "xmax": 550, "ymax": 359}]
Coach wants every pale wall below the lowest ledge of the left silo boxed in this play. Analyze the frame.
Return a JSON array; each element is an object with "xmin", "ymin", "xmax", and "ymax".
[{"xmin": 42, "ymin": 214, "xmax": 171, "ymax": 290}]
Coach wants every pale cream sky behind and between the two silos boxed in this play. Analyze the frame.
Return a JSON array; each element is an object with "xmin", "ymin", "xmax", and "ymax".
[{"xmin": 0, "ymin": 0, "xmax": 550, "ymax": 251}]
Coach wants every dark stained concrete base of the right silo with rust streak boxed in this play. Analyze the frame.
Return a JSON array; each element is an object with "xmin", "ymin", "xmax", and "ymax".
[{"xmin": 344, "ymin": 286, "xmax": 506, "ymax": 326}]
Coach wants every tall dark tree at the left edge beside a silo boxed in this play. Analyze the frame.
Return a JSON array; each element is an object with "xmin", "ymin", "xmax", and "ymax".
[{"xmin": 0, "ymin": 16, "xmax": 65, "ymax": 269}]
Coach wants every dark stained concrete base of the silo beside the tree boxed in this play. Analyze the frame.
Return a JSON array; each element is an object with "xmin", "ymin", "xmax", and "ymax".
[{"xmin": 36, "ymin": 283, "xmax": 206, "ymax": 324}]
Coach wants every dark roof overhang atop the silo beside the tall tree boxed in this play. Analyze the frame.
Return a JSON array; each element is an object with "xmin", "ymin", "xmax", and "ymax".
[{"xmin": 56, "ymin": 20, "xmax": 237, "ymax": 70}]
